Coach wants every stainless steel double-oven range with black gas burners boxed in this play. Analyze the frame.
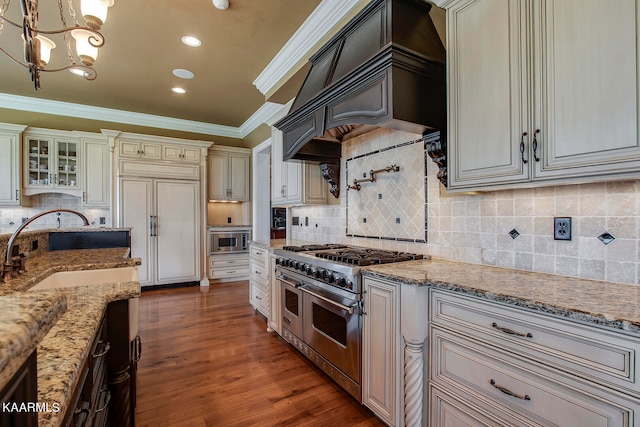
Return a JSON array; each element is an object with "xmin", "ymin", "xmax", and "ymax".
[{"xmin": 275, "ymin": 244, "xmax": 422, "ymax": 402}]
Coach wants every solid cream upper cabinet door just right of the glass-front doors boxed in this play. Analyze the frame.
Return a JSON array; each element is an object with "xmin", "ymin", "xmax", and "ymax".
[{"xmin": 82, "ymin": 141, "xmax": 109, "ymax": 208}]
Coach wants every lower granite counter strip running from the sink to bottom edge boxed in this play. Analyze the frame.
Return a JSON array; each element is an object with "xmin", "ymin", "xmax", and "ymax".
[{"xmin": 34, "ymin": 281, "xmax": 140, "ymax": 427}]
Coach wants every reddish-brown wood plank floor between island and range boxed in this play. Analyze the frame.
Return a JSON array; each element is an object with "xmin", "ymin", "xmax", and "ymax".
[{"xmin": 136, "ymin": 281, "xmax": 384, "ymax": 427}]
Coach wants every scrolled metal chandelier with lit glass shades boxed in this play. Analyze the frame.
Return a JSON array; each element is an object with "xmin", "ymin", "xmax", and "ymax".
[{"xmin": 0, "ymin": 0, "xmax": 113, "ymax": 90}]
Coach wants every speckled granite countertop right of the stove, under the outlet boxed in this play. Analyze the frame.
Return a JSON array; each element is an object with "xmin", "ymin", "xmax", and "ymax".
[{"xmin": 361, "ymin": 258, "xmax": 640, "ymax": 334}]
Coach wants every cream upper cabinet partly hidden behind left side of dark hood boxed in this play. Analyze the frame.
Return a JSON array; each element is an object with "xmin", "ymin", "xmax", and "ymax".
[{"xmin": 271, "ymin": 128, "xmax": 328, "ymax": 206}]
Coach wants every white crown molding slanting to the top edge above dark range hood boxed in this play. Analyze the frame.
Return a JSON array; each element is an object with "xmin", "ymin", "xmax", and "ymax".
[{"xmin": 253, "ymin": 0, "xmax": 368, "ymax": 95}]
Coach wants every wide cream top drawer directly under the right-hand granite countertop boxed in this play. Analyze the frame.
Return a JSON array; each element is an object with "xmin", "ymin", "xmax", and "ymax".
[{"xmin": 431, "ymin": 290, "xmax": 640, "ymax": 392}]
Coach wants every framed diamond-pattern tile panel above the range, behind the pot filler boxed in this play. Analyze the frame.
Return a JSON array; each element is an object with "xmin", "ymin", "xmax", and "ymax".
[{"xmin": 345, "ymin": 141, "xmax": 426, "ymax": 242}]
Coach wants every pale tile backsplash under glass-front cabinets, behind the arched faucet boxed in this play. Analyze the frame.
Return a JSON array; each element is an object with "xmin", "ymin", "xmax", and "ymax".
[{"xmin": 0, "ymin": 194, "xmax": 111, "ymax": 234}]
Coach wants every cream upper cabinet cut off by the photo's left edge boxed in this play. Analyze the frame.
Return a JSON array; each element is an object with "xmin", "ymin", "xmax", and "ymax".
[{"xmin": 0, "ymin": 123, "xmax": 25, "ymax": 207}]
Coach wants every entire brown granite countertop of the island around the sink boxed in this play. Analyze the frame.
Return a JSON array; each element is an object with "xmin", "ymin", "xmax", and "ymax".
[{"xmin": 0, "ymin": 248, "xmax": 141, "ymax": 426}]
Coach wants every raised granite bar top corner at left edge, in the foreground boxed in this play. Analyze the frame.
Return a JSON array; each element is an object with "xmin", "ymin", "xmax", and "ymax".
[{"xmin": 0, "ymin": 290, "xmax": 67, "ymax": 389}]
